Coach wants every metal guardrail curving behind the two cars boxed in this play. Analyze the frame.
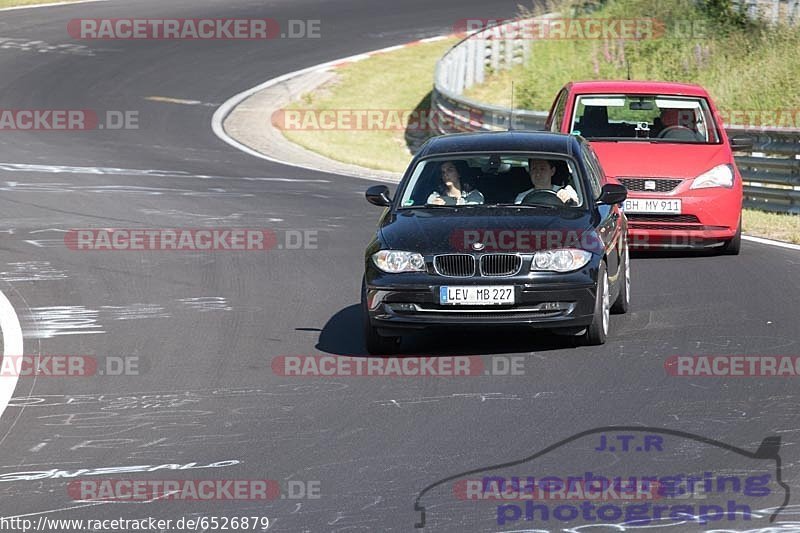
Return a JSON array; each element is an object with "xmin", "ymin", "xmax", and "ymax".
[{"xmin": 431, "ymin": 15, "xmax": 800, "ymax": 214}]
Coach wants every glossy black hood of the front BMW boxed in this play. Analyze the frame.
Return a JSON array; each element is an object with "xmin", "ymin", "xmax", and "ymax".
[{"xmin": 381, "ymin": 207, "xmax": 596, "ymax": 254}]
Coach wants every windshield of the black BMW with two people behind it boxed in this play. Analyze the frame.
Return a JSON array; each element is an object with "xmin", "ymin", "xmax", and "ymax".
[{"xmin": 400, "ymin": 153, "xmax": 585, "ymax": 209}]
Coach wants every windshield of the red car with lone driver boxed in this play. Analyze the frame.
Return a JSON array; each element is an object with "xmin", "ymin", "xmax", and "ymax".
[{"xmin": 570, "ymin": 94, "xmax": 720, "ymax": 144}]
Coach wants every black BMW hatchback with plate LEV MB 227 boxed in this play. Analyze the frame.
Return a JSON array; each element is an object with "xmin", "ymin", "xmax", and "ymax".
[{"xmin": 361, "ymin": 131, "xmax": 630, "ymax": 354}]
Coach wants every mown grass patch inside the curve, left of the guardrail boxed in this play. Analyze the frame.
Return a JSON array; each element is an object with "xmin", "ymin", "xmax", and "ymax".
[{"xmin": 283, "ymin": 40, "xmax": 456, "ymax": 172}]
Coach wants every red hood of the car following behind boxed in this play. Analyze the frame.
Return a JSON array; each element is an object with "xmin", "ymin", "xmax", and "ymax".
[{"xmin": 591, "ymin": 141, "xmax": 733, "ymax": 179}]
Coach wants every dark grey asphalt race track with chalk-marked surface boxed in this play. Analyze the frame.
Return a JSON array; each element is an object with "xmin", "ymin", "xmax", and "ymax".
[{"xmin": 0, "ymin": 0, "xmax": 800, "ymax": 532}]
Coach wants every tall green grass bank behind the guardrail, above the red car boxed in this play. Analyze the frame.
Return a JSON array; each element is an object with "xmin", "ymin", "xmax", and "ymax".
[{"xmin": 466, "ymin": 0, "xmax": 800, "ymax": 111}]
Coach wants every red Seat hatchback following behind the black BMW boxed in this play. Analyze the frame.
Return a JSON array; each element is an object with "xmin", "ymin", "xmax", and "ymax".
[{"xmin": 546, "ymin": 81, "xmax": 752, "ymax": 255}]
